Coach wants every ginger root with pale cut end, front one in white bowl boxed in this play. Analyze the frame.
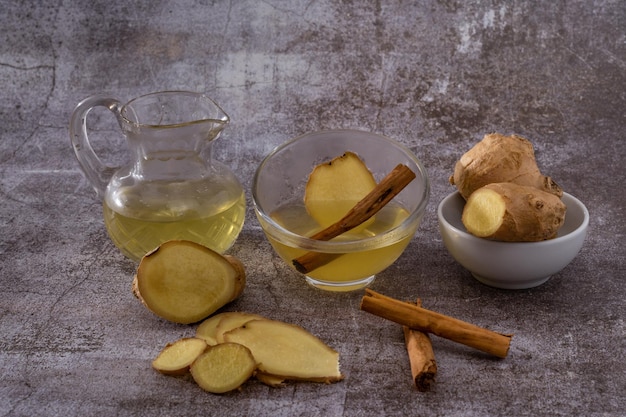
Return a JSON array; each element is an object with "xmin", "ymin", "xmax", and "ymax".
[{"xmin": 461, "ymin": 182, "xmax": 566, "ymax": 242}]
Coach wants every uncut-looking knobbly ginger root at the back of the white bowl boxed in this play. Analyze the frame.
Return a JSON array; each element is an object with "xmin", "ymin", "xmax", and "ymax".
[{"xmin": 450, "ymin": 133, "xmax": 563, "ymax": 200}]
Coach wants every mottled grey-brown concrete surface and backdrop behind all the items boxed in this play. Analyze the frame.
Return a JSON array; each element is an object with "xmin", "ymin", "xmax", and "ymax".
[{"xmin": 0, "ymin": 0, "xmax": 626, "ymax": 417}]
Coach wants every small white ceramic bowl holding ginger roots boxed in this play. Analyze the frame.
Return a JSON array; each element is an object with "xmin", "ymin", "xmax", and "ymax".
[{"xmin": 437, "ymin": 192, "xmax": 589, "ymax": 289}]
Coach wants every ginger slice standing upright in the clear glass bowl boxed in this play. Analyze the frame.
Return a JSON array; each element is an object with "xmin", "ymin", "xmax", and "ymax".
[{"xmin": 304, "ymin": 151, "xmax": 376, "ymax": 228}]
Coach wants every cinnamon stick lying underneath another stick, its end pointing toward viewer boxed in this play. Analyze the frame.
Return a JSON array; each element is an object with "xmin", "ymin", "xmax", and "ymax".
[{"xmin": 402, "ymin": 300, "xmax": 437, "ymax": 392}]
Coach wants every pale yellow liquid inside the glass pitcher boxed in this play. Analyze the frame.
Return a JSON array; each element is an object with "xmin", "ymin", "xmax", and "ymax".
[{"xmin": 103, "ymin": 192, "xmax": 246, "ymax": 261}]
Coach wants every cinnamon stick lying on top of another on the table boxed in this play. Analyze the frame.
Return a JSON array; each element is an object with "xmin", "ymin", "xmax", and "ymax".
[{"xmin": 361, "ymin": 289, "xmax": 513, "ymax": 358}]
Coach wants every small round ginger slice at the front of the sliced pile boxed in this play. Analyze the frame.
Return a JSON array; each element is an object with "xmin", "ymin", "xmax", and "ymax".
[{"xmin": 190, "ymin": 343, "xmax": 257, "ymax": 394}]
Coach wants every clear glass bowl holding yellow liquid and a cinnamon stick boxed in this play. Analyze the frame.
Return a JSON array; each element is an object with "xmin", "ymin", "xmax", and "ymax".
[{"xmin": 252, "ymin": 130, "xmax": 430, "ymax": 291}]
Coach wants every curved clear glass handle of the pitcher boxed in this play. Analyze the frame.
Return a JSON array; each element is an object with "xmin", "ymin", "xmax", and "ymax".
[{"xmin": 70, "ymin": 95, "xmax": 122, "ymax": 199}]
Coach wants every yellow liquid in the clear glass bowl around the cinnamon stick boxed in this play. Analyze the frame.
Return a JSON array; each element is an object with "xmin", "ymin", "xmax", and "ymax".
[{"xmin": 269, "ymin": 203, "xmax": 418, "ymax": 291}]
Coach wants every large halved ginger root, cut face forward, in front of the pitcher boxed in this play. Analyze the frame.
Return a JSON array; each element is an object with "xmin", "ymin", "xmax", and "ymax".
[{"xmin": 133, "ymin": 240, "xmax": 246, "ymax": 324}]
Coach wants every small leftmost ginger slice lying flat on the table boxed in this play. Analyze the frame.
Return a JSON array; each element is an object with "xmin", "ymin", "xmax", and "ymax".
[{"xmin": 152, "ymin": 337, "xmax": 208, "ymax": 375}]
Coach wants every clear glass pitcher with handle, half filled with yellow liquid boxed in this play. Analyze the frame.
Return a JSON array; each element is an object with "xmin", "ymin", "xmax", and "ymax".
[{"xmin": 70, "ymin": 91, "xmax": 246, "ymax": 261}]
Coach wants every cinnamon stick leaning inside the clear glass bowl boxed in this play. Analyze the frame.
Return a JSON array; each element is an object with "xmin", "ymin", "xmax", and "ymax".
[{"xmin": 292, "ymin": 164, "xmax": 415, "ymax": 274}]
